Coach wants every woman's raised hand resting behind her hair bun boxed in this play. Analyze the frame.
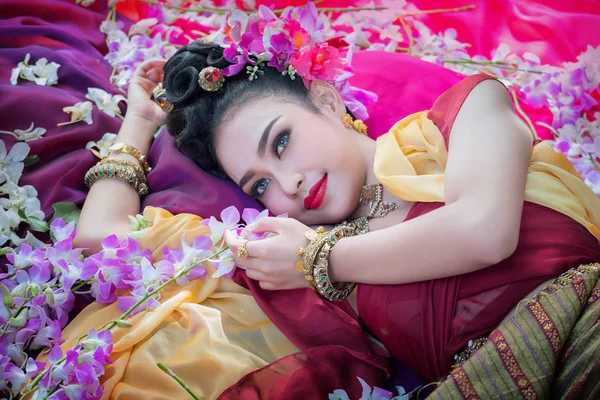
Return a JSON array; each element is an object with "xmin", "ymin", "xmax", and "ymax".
[{"xmin": 127, "ymin": 60, "xmax": 167, "ymax": 126}]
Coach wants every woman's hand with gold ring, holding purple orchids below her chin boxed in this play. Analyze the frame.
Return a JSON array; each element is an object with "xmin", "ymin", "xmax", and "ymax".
[{"xmin": 225, "ymin": 217, "xmax": 310, "ymax": 290}]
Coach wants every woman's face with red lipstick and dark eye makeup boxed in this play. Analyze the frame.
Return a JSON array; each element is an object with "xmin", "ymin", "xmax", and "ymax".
[{"xmin": 215, "ymin": 92, "xmax": 367, "ymax": 225}]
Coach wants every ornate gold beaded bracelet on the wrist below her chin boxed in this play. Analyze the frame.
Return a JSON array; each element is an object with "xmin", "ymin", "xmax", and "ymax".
[{"xmin": 303, "ymin": 226, "xmax": 357, "ymax": 300}]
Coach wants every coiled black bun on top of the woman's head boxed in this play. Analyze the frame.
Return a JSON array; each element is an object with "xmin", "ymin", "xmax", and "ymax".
[{"xmin": 164, "ymin": 41, "xmax": 230, "ymax": 106}]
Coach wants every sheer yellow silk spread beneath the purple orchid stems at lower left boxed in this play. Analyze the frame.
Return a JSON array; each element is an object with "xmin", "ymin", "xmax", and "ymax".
[{"xmin": 45, "ymin": 207, "xmax": 298, "ymax": 400}]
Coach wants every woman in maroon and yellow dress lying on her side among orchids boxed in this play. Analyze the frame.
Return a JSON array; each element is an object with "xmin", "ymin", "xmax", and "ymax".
[{"xmin": 54, "ymin": 6, "xmax": 600, "ymax": 399}]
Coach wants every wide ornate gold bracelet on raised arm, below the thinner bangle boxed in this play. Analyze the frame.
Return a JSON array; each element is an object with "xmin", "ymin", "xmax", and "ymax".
[{"xmin": 85, "ymin": 159, "xmax": 148, "ymax": 197}]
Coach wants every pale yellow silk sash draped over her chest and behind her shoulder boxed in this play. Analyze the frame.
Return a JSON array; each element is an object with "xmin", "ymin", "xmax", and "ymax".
[{"xmin": 374, "ymin": 111, "xmax": 600, "ymax": 240}]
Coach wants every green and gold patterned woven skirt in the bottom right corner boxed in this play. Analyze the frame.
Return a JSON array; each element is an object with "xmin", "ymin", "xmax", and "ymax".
[{"xmin": 428, "ymin": 263, "xmax": 600, "ymax": 399}]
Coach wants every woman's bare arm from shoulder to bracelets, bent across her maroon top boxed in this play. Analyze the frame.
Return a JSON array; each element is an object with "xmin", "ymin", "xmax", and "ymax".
[{"xmin": 330, "ymin": 80, "xmax": 532, "ymax": 284}]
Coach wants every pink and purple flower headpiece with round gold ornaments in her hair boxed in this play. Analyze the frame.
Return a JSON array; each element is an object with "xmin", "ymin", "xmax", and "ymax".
[{"xmin": 155, "ymin": 2, "xmax": 377, "ymax": 120}]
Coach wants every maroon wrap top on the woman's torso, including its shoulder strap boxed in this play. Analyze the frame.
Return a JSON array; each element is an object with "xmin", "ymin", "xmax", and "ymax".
[{"xmin": 358, "ymin": 76, "xmax": 600, "ymax": 381}]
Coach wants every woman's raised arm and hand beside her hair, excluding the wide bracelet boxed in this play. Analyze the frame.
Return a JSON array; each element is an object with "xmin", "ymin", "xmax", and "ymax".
[{"xmin": 74, "ymin": 60, "xmax": 166, "ymax": 254}]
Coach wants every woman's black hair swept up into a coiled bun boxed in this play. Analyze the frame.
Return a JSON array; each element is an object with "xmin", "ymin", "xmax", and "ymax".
[{"xmin": 159, "ymin": 41, "xmax": 319, "ymax": 179}]
